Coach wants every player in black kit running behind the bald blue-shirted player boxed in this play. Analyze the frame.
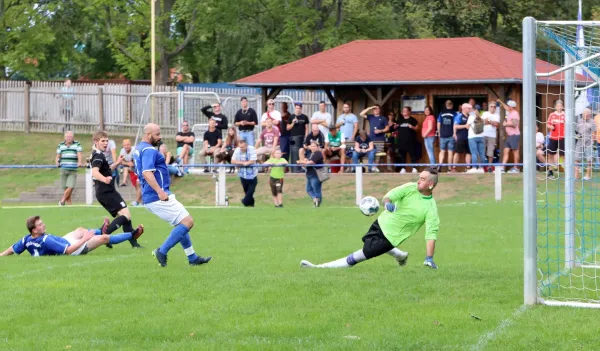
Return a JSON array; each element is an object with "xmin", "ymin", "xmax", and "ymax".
[{"xmin": 90, "ymin": 131, "xmax": 143, "ymax": 248}]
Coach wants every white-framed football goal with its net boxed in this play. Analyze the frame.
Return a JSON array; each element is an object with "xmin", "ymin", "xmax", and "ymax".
[{"xmin": 523, "ymin": 18, "xmax": 600, "ymax": 307}]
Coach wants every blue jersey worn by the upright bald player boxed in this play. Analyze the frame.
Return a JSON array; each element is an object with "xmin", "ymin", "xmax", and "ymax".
[{"xmin": 133, "ymin": 141, "xmax": 171, "ymax": 204}]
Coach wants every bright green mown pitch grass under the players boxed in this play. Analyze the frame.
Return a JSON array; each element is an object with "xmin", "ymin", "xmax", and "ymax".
[{"xmin": 0, "ymin": 197, "xmax": 599, "ymax": 350}]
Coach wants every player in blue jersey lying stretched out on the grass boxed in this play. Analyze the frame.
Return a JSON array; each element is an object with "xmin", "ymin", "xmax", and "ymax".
[{"xmin": 0, "ymin": 216, "xmax": 144, "ymax": 256}]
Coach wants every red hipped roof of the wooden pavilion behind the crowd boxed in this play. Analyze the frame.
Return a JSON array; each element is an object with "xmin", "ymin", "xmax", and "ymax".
[{"xmin": 234, "ymin": 38, "xmax": 584, "ymax": 86}]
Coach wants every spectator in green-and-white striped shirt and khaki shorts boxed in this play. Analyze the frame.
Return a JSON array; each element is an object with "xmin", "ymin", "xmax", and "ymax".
[{"xmin": 54, "ymin": 131, "xmax": 83, "ymax": 206}]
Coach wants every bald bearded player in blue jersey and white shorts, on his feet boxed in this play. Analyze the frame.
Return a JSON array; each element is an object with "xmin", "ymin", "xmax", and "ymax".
[{"xmin": 133, "ymin": 123, "xmax": 212, "ymax": 267}]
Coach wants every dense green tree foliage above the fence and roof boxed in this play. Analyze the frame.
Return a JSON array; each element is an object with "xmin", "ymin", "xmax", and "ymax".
[{"xmin": 0, "ymin": 0, "xmax": 600, "ymax": 83}]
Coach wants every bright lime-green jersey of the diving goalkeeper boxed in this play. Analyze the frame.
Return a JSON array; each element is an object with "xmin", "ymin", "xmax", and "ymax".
[{"xmin": 378, "ymin": 183, "xmax": 440, "ymax": 246}]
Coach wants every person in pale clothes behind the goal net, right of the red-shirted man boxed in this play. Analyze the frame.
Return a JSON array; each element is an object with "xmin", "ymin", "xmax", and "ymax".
[{"xmin": 575, "ymin": 108, "xmax": 596, "ymax": 180}]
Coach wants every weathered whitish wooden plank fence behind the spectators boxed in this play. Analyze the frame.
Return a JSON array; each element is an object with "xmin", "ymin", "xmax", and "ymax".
[{"xmin": 0, "ymin": 81, "xmax": 334, "ymax": 136}]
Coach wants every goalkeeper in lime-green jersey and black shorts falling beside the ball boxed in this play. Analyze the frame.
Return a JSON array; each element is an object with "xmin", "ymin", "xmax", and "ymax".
[{"xmin": 300, "ymin": 168, "xmax": 440, "ymax": 268}]
